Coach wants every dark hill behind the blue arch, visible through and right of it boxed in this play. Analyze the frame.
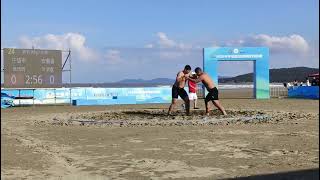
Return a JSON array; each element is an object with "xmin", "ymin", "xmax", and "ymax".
[{"xmin": 219, "ymin": 67, "xmax": 319, "ymax": 83}]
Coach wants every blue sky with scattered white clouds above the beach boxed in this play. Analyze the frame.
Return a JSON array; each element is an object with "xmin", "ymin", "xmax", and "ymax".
[{"xmin": 1, "ymin": 0, "xmax": 319, "ymax": 83}]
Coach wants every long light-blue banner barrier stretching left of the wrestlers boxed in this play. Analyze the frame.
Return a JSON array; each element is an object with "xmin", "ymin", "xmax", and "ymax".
[{"xmin": 1, "ymin": 87, "xmax": 171, "ymax": 105}]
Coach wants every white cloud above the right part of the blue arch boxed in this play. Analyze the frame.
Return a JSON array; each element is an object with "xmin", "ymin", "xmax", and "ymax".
[{"xmin": 226, "ymin": 34, "xmax": 310, "ymax": 55}]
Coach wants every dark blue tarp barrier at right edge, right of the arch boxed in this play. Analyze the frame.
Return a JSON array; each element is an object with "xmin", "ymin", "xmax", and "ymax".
[{"xmin": 288, "ymin": 86, "xmax": 319, "ymax": 99}]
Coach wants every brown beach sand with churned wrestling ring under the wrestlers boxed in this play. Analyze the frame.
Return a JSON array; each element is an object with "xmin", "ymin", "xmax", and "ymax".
[{"xmin": 1, "ymin": 99, "xmax": 319, "ymax": 179}]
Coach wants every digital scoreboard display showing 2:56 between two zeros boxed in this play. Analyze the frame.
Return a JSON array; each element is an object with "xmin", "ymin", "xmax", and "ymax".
[{"xmin": 3, "ymin": 48, "xmax": 62, "ymax": 88}]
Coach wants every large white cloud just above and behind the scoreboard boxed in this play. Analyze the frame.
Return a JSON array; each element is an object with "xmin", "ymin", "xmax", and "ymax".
[{"xmin": 19, "ymin": 33, "xmax": 99, "ymax": 61}]
